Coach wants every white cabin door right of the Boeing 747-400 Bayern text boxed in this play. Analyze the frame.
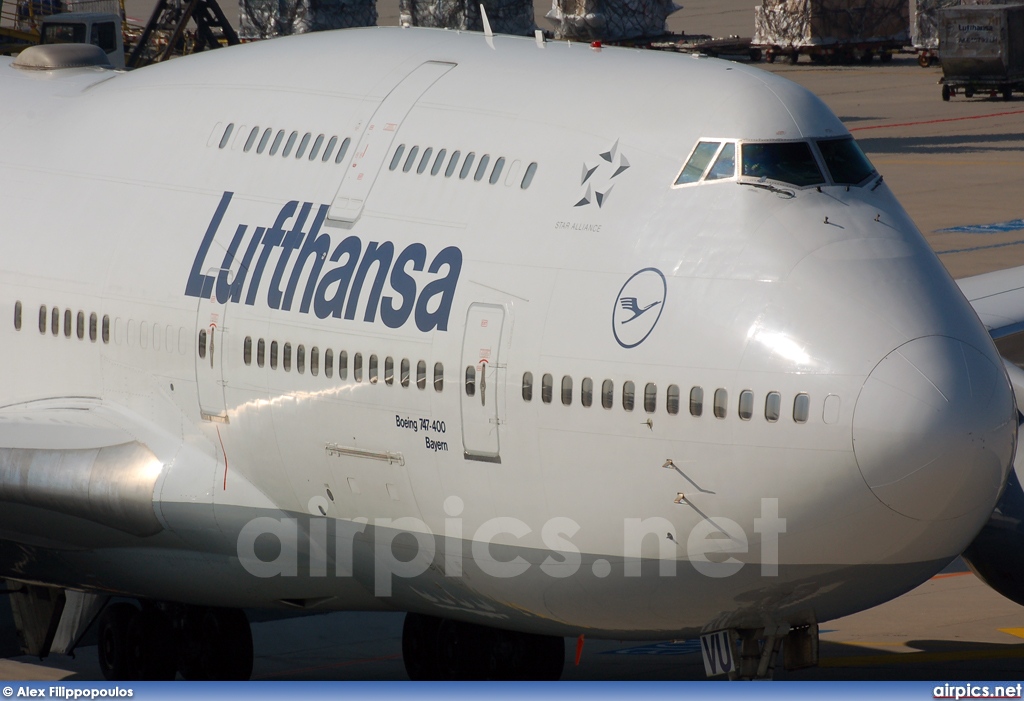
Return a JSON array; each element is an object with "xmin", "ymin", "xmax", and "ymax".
[{"xmin": 461, "ymin": 304, "xmax": 505, "ymax": 463}]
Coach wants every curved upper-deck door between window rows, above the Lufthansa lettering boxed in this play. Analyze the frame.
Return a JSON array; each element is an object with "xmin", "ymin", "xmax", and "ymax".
[{"xmin": 327, "ymin": 61, "xmax": 456, "ymax": 222}]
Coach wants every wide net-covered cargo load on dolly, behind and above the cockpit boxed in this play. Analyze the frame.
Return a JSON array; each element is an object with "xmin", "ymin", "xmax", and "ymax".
[{"xmin": 752, "ymin": 0, "xmax": 909, "ymax": 63}]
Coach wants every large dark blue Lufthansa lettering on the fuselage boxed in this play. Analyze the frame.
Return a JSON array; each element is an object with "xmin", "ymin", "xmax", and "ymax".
[{"xmin": 185, "ymin": 192, "xmax": 463, "ymax": 331}]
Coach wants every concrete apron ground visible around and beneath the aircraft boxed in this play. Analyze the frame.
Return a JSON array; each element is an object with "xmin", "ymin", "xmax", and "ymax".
[{"xmin": 0, "ymin": 0, "xmax": 1024, "ymax": 683}]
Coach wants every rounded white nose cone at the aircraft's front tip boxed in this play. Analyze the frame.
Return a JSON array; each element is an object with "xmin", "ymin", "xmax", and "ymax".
[{"xmin": 853, "ymin": 336, "xmax": 1016, "ymax": 521}]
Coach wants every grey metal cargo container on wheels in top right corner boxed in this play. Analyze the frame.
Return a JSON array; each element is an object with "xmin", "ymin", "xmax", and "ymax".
[{"xmin": 939, "ymin": 5, "xmax": 1024, "ymax": 100}]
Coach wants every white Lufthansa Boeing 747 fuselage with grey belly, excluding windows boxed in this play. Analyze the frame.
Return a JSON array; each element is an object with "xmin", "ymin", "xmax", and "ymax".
[{"xmin": 0, "ymin": 29, "xmax": 1017, "ymax": 679}]
